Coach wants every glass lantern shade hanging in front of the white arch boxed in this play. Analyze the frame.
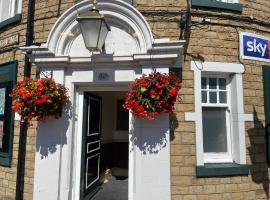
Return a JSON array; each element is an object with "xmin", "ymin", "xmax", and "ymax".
[{"xmin": 77, "ymin": 13, "xmax": 110, "ymax": 51}]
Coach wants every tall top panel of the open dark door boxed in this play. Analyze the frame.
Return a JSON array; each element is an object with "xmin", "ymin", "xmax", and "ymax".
[{"xmin": 89, "ymin": 99, "xmax": 101, "ymax": 135}]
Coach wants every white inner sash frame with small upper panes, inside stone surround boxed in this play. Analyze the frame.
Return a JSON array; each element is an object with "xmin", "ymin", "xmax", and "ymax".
[{"xmin": 201, "ymin": 73, "xmax": 233, "ymax": 163}]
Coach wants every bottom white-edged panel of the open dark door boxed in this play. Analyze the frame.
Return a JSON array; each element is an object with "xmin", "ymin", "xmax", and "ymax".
[{"xmin": 86, "ymin": 154, "xmax": 100, "ymax": 189}]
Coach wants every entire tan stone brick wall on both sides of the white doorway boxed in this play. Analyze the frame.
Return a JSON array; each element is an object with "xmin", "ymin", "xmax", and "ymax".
[{"xmin": 0, "ymin": 0, "xmax": 270, "ymax": 200}]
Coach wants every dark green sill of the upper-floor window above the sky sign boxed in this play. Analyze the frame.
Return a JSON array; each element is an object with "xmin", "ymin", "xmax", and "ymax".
[{"xmin": 191, "ymin": 0, "xmax": 243, "ymax": 12}]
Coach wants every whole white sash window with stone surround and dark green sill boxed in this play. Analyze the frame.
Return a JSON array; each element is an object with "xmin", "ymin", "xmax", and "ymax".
[{"xmin": 185, "ymin": 61, "xmax": 253, "ymax": 176}]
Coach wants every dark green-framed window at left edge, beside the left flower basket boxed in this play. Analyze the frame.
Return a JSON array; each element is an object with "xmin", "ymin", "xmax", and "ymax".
[{"xmin": 0, "ymin": 62, "xmax": 17, "ymax": 166}]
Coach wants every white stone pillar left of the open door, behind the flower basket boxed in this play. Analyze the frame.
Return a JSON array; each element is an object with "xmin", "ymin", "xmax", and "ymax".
[{"xmin": 33, "ymin": 69, "xmax": 70, "ymax": 200}]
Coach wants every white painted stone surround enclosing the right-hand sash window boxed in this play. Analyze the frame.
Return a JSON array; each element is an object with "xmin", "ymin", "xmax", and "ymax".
[{"xmin": 185, "ymin": 61, "xmax": 253, "ymax": 166}]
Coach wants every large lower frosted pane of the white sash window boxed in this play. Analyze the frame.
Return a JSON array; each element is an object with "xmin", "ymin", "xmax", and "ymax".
[{"xmin": 202, "ymin": 107, "xmax": 227, "ymax": 153}]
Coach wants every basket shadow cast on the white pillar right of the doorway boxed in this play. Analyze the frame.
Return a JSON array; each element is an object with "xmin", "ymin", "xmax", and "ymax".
[{"xmin": 130, "ymin": 114, "xmax": 169, "ymax": 154}]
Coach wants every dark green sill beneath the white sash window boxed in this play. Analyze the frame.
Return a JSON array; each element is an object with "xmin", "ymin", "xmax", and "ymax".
[{"xmin": 196, "ymin": 163, "xmax": 249, "ymax": 177}]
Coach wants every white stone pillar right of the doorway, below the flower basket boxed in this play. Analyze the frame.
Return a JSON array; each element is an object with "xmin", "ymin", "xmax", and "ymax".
[{"xmin": 129, "ymin": 114, "xmax": 171, "ymax": 200}]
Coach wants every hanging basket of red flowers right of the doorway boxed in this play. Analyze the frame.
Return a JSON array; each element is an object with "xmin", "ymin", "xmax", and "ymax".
[{"xmin": 123, "ymin": 71, "xmax": 182, "ymax": 120}]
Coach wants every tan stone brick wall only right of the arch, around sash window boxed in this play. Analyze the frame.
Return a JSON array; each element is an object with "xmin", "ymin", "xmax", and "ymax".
[{"xmin": 135, "ymin": 0, "xmax": 270, "ymax": 200}]
